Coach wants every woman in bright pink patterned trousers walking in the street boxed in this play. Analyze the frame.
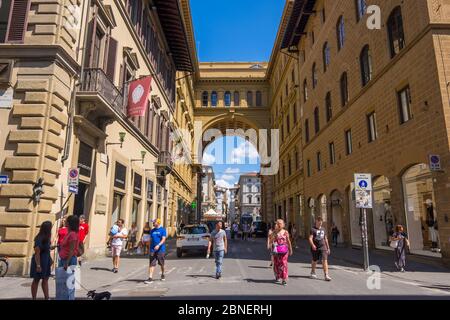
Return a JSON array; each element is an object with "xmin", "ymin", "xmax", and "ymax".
[{"xmin": 270, "ymin": 219, "xmax": 292, "ymax": 286}]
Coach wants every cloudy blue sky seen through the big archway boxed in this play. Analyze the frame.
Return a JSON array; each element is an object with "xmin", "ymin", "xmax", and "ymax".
[{"xmin": 203, "ymin": 137, "xmax": 260, "ymax": 188}]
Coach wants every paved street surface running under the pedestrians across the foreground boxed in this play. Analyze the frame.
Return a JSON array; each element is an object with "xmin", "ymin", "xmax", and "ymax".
[{"xmin": 0, "ymin": 239, "xmax": 450, "ymax": 300}]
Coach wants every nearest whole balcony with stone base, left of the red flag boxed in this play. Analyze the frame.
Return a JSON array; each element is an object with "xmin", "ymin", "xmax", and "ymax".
[{"xmin": 77, "ymin": 69, "xmax": 126, "ymax": 116}]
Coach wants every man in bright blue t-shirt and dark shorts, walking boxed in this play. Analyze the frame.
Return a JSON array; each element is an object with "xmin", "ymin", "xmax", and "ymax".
[{"xmin": 145, "ymin": 219, "xmax": 167, "ymax": 284}]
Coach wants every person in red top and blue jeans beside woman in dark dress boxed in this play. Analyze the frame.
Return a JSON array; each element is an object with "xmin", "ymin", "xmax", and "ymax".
[{"xmin": 56, "ymin": 215, "xmax": 82, "ymax": 300}]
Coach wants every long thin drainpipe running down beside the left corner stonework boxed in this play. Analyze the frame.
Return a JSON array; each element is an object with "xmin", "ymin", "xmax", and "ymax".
[{"xmin": 61, "ymin": 0, "xmax": 91, "ymax": 165}]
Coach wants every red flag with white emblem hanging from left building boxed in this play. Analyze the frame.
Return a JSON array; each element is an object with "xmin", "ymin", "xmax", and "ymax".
[{"xmin": 127, "ymin": 76, "xmax": 152, "ymax": 117}]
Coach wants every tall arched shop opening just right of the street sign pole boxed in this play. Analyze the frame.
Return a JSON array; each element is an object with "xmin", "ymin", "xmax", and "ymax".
[{"xmin": 372, "ymin": 176, "xmax": 395, "ymax": 249}]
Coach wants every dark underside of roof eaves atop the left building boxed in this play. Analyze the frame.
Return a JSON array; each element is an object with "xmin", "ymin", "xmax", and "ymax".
[{"xmin": 153, "ymin": 0, "xmax": 193, "ymax": 72}]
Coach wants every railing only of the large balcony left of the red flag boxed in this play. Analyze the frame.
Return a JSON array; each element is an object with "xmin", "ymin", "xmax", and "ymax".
[{"xmin": 80, "ymin": 69, "xmax": 126, "ymax": 115}]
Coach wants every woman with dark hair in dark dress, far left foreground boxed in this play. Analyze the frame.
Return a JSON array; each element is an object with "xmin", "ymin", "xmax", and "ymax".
[{"xmin": 30, "ymin": 221, "xmax": 55, "ymax": 300}]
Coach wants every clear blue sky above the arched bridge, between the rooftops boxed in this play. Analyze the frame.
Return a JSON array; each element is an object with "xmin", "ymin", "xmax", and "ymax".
[{"xmin": 191, "ymin": 0, "xmax": 285, "ymax": 62}]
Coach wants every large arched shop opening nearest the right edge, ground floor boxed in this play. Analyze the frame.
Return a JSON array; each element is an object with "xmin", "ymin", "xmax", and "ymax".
[{"xmin": 402, "ymin": 164, "xmax": 440, "ymax": 256}]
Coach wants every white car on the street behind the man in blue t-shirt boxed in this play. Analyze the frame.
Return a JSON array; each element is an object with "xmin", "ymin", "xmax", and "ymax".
[{"xmin": 177, "ymin": 224, "xmax": 211, "ymax": 258}]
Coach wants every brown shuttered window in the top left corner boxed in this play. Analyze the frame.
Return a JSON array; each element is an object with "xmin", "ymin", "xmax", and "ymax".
[{"xmin": 4, "ymin": 0, "xmax": 30, "ymax": 42}]
